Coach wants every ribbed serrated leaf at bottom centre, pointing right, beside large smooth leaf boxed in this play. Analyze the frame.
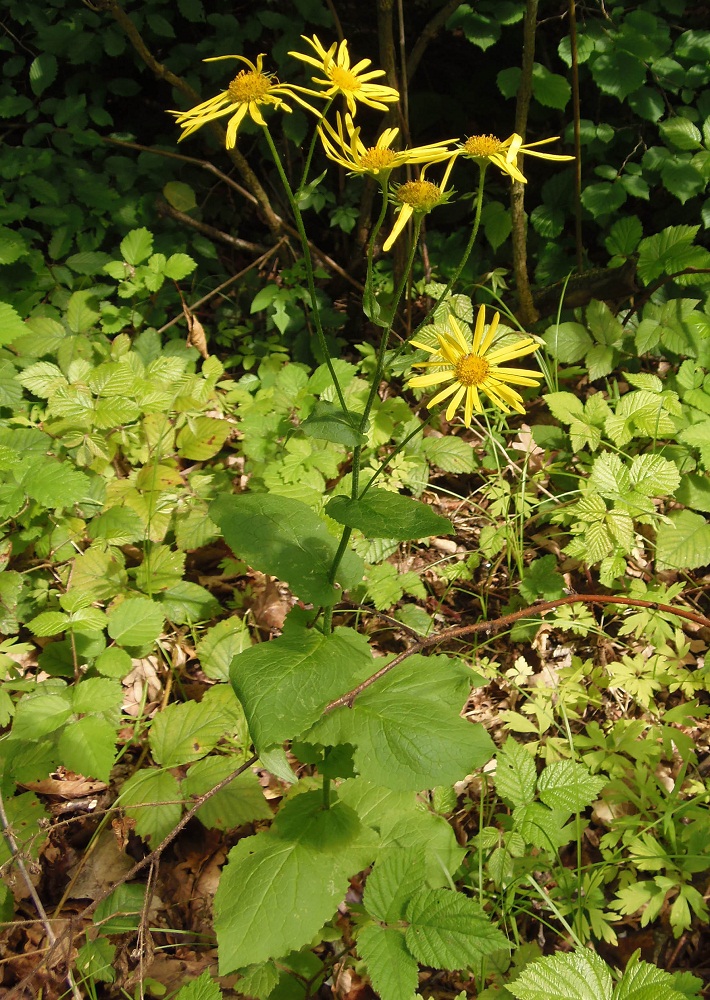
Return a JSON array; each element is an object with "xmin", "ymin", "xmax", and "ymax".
[{"xmin": 405, "ymin": 889, "xmax": 509, "ymax": 971}]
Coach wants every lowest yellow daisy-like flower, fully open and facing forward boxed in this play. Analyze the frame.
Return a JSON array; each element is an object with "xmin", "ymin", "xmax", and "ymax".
[{"xmin": 408, "ymin": 306, "xmax": 542, "ymax": 427}]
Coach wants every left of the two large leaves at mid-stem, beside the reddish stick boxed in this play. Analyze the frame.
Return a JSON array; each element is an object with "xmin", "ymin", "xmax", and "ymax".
[{"xmin": 230, "ymin": 628, "xmax": 375, "ymax": 751}]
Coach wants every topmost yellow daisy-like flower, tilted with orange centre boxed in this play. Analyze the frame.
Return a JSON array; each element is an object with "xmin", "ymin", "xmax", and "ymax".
[{"xmin": 289, "ymin": 35, "xmax": 399, "ymax": 115}]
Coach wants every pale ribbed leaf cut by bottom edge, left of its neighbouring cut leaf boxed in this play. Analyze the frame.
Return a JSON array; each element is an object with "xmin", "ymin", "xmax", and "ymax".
[{"xmin": 506, "ymin": 951, "xmax": 613, "ymax": 1000}]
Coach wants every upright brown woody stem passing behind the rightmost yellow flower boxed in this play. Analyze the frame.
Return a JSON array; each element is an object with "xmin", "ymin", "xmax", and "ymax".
[{"xmin": 510, "ymin": 0, "xmax": 539, "ymax": 327}]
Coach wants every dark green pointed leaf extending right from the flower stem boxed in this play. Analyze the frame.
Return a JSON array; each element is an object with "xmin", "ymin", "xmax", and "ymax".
[{"xmin": 325, "ymin": 489, "xmax": 454, "ymax": 542}]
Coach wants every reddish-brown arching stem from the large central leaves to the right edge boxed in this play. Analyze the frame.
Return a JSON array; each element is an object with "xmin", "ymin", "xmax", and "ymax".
[{"xmin": 323, "ymin": 594, "xmax": 710, "ymax": 715}]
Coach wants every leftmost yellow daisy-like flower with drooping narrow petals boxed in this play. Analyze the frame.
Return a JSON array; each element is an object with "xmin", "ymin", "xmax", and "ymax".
[{"xmin": 170, "ymin": 53, "xmax": 318, "ymax": 149}]
